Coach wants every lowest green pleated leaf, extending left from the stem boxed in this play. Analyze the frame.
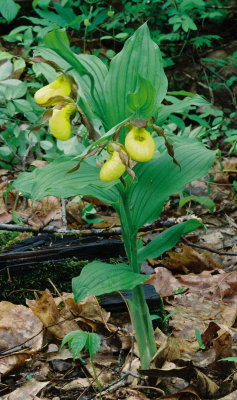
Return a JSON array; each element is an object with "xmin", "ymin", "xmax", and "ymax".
[{"xmin": 72, "ymin": 261, "xmax": 149, "ymax": 302}]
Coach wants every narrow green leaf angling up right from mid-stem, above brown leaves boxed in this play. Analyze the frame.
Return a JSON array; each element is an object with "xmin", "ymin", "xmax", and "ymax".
[{"xmin": 138, "ymin": 219, "xmax": 203, "ymax": 263}]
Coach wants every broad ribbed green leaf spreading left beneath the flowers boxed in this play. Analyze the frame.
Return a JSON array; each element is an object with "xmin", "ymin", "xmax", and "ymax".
[{"xmin": 14, "ymin": 157, "xmax": 118, "ymax": 204}]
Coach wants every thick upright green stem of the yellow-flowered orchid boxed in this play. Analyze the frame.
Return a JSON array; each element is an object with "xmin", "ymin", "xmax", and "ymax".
[{"xmin": 119, "ymin": 188, "xmax": 156, "ymax": 369}]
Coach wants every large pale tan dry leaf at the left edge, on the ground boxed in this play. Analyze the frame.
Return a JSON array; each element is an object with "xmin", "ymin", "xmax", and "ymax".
[{"xmin": 0, "ymin": 301, "xmax": 43, "ymax": 374}]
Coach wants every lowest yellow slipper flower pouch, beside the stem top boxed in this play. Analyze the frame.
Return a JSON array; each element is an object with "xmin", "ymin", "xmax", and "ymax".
[{"xmin": 100, "ymin": 151, "xmax": 126, "ymax": 182}]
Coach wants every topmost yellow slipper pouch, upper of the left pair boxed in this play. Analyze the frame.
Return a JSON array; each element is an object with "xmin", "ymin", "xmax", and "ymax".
[{"xmin": 34, "ymin": 74, "xmax": 72, "ymax": 107}]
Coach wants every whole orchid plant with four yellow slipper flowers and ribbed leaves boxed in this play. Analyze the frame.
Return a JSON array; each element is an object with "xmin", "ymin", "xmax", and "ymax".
[{"xmin": 14, "ymin": 24, "xmax": 215, "ymax": 369}]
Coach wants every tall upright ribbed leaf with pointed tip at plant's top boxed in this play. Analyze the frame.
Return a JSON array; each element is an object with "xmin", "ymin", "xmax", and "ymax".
[{"xmin": 105, "ymin": 24, "xmax": 167, "ymax": 129}]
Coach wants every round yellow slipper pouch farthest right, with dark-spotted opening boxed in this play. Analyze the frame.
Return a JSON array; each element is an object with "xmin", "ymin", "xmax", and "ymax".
[{"xmin": 125, "ymin": 126, "xmax": 156, "ymax": 162}]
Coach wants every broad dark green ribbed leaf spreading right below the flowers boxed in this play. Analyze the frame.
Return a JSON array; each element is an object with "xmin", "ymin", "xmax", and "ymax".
[{"xmin": 129, "ymin": 142, "xmax": 215, "ymax": 229}]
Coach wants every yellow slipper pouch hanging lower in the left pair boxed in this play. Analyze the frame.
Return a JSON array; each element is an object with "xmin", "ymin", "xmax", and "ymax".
[{"xmin": 49, "ymin": 104, "xmax": 76, "ymax": 140}]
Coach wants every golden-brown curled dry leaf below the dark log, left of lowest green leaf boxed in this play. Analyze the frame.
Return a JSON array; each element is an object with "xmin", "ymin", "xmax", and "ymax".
[{"xmin": 26, "ymin": 290, "xmax": 79, "ymax": 339}]
